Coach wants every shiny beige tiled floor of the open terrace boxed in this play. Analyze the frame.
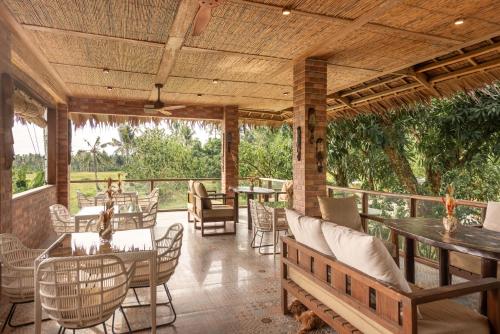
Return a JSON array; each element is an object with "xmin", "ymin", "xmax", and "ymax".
[{"xmin": 0, "ymin": 210, "xmax": 480, "ymax": 334}]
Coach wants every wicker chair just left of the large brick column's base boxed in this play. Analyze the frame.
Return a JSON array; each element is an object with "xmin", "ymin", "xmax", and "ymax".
[{"xmin": 250, "ymin": 199, "xmax": 288, "ymax": 255}]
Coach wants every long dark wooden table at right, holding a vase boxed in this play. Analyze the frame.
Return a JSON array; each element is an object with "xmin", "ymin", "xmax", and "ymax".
[{"xmin": 376, "ymin": 217, "xmax": 500, "ymax": 312}]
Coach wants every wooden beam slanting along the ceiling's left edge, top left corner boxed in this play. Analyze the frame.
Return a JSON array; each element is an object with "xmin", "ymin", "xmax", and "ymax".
[{"xmin": 0, "ymin": 1, "xmax": 71, "ymax": 103}]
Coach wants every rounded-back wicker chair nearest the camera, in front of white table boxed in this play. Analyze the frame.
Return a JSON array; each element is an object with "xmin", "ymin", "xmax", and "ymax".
[{"xmin": 38, "ymin": 255, "xmax": 135, "ymax": 332}]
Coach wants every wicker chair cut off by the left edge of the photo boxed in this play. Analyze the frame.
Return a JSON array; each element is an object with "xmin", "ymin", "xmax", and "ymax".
[{"xmin": 0, "ymin": 233, "xmax": 47, "ymax": 333}]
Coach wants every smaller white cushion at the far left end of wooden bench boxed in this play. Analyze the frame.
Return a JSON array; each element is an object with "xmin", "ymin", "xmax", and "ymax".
[{"xmin": 285, "ymin": 209, "xmax": 333, "ymax": 256}]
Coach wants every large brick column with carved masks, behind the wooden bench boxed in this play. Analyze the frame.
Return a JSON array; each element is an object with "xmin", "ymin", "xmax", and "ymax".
[{"xmin": 293, "ymin": 58, "xmax": 327, "ymax": 216}]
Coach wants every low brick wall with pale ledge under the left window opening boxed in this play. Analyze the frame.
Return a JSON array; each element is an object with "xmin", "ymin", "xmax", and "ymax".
[{"xmin": 12, "ymin": 185, "xmax": 57, "ymax": 248}]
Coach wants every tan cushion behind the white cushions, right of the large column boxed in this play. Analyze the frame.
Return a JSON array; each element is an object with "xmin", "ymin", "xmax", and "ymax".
[{"xmin": 318, "ymin": 196, "xmax": 363, "ymax": 231}]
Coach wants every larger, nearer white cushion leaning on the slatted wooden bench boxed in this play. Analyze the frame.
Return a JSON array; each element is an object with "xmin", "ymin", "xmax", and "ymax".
[{"xmin": 321, "ymin": 222, "xmax": 411, "ymax": 292}]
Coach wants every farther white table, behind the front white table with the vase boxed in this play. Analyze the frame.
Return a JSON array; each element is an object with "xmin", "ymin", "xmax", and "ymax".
[{"xmin": 75, "ymin": 203, "xmax": 142, "ymax": 232}]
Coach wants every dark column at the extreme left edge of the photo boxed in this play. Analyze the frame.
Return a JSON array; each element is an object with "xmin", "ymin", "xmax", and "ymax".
[{"xmin": 0, "ymin": 73, "xmax": 14, "ymax": 233}]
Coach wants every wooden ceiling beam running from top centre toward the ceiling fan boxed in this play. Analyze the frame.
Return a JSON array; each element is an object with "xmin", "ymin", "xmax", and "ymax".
[{"xmin": 149, "ymin": 0, "xmax": 199, "ymax": 100}]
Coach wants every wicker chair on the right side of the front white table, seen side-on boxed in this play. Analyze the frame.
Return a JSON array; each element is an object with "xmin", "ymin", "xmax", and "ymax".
[{"xmin": 113, "ymin": 224, "xmax": 184, "ymax": 333}]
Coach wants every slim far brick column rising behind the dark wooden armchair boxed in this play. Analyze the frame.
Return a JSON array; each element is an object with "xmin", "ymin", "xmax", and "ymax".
[{"xmin": 221, "ymin": 106, "xmax": 240, "ymax": 202}]
